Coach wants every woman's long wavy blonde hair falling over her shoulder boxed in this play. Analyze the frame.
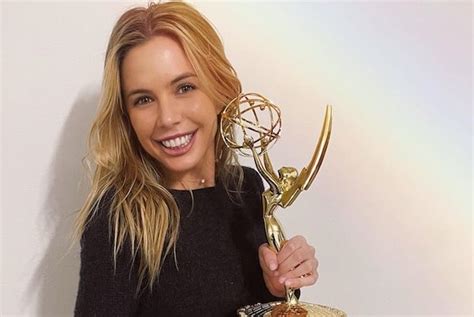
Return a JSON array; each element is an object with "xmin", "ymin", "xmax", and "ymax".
[{"xmin": 73, "ymin": 2, "xmax": 243, "ymax": 294}]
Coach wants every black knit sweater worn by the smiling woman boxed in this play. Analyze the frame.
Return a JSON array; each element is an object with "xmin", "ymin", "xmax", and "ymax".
[{"xmin": 75, "ymin": 168, "xmax": 280, "ymax": 316}]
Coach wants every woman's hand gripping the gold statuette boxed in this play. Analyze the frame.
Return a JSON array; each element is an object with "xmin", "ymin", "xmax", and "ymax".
[{"xmin": 258, "ymin": 236, "xmax": 319, "ymax": 297}]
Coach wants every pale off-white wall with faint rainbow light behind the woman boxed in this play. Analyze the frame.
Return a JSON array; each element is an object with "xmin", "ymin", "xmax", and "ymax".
[{"xmin": 1, "ymin": 1, "xmax": 473, "ymax": 316}]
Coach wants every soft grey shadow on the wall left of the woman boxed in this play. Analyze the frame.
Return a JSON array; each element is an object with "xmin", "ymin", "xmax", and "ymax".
[{"xmin": 24, "ymin": 85, "xmax": 100, "ymax": 317}]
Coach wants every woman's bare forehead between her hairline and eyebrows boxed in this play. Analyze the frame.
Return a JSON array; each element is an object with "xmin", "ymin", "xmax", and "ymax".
[{"xmin": 121, "ymin": 35, "xmax": 193, "ymax": 90}]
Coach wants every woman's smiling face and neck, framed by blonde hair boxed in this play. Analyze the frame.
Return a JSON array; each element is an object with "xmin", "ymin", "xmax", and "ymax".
[{"xmin": 121, "ymin": 36, "xmax": 217, "ymax": 188}]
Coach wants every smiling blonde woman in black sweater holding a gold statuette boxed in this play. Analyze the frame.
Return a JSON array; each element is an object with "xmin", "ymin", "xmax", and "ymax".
[{"xmin": 75, "ymin": 2, "xmax": 317, "ymax": 316}]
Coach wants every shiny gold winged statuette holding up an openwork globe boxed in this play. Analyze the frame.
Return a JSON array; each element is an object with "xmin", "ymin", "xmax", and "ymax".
[{"xmin": 220, "ymin": 93, "xmax": 346, "ymax": 316}]
